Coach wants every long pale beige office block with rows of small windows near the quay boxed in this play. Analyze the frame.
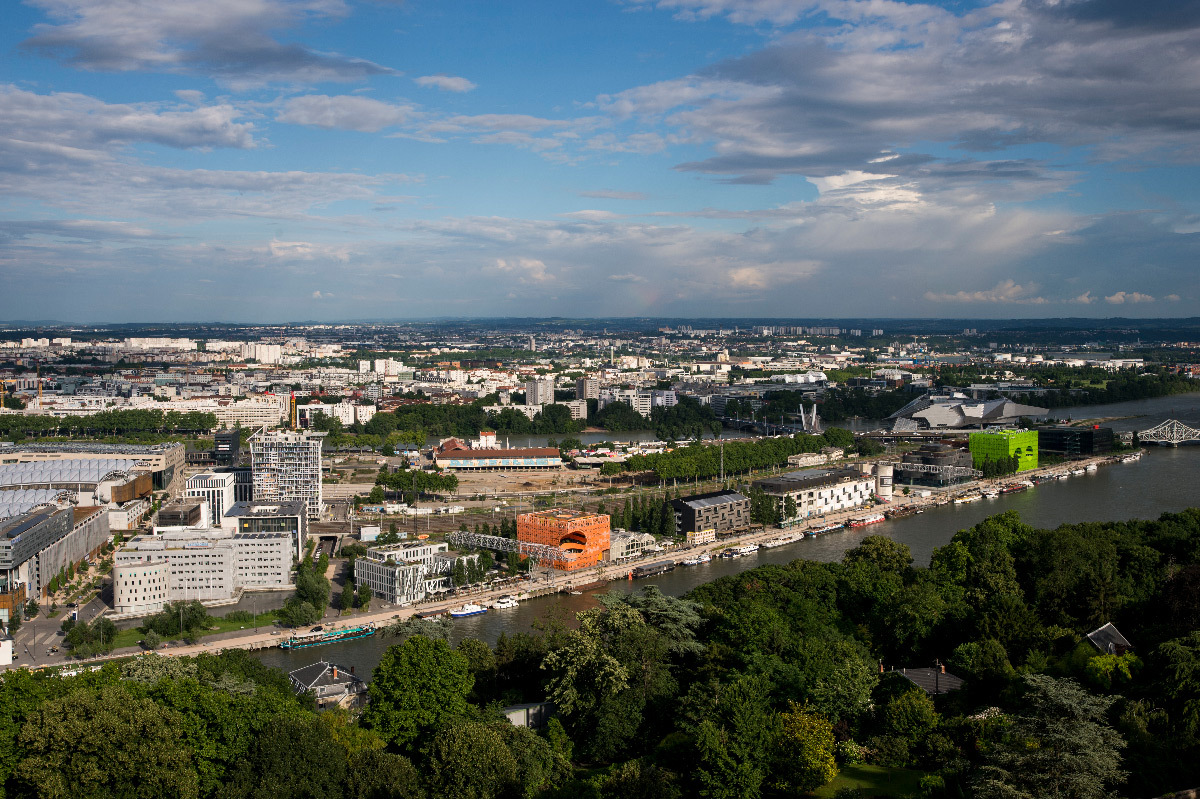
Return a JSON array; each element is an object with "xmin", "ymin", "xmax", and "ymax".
[{"xmin": 113, "ymin": 528, "xmax": 293, "ymax": 615}]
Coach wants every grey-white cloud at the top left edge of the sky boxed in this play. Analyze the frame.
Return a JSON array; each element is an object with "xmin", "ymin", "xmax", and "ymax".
[{"xmin": 23, "ymin": 0, "xmax": 396, "ymax": 86}]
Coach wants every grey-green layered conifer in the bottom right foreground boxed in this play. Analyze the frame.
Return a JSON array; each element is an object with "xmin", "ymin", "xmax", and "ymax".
[{"xmin": 973, "ymin": 674, "xmax": 1126, "ymax": 799}]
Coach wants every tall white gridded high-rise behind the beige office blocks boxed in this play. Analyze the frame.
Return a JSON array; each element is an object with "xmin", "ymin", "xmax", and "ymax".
[{"xmin": 250, "ymin": 431, "xmax": 325, "ymax": 521}]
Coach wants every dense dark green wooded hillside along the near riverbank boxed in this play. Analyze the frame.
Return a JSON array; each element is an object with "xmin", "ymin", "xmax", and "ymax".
[{"xmin": 7, "ymin": 509, "xmax": 1200, "ymax": 799}]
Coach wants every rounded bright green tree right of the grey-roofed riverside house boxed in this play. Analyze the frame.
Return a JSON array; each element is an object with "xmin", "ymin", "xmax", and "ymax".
[{"xmin": 362, "ymin": 635, "xmax": 474, "ymax": 749}]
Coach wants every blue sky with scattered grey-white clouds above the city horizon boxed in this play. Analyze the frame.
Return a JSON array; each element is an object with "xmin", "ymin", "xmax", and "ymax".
[{"xmin": 0, "ymin": 0, "xmax": 1200, "ymax": 323}]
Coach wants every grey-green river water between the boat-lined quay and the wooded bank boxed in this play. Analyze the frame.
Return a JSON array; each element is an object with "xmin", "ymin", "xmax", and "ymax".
[{"xmin": 258, "ymin": 394, "xmax": 1200, "ymax": 674}]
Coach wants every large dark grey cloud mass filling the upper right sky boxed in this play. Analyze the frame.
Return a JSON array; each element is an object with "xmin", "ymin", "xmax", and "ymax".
[{"xmin": 598, "ymin": 0, "xmax": 1200, "ymax": 183}]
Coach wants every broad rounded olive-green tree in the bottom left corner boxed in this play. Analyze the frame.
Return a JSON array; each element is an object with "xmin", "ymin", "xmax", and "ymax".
[{"xmin": 12, "ymin": 684, "xmax": 199, "ymax": 799}]
